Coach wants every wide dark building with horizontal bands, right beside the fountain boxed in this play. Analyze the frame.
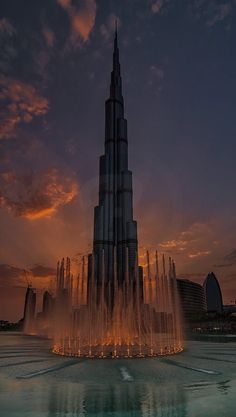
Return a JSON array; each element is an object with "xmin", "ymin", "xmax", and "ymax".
[{"xmin": 177, "ymin": 279, "xmax": 206, "ymax": 318}]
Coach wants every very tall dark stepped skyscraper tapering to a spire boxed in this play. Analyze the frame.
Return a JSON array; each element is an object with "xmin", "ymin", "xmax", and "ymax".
[{"xmin": 89, "ymin": 29, "xmax": 141, "ymax": 299}]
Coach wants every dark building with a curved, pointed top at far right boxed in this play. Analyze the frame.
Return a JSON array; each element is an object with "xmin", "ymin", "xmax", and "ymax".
[{"xmin": 203, "ymin": 272, "xmax": 223, "ymax": 313}]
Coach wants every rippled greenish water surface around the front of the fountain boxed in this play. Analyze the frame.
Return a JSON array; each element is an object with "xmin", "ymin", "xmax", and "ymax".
[{"xmin": 0, "ymin": 333, "xmax": 236, "ymax": 417}]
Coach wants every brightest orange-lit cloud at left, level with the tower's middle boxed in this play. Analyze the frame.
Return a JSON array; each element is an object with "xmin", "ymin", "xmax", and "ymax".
[{"xmin": 0, "ymin": 169, "xmax": 78, "ymax": 220}]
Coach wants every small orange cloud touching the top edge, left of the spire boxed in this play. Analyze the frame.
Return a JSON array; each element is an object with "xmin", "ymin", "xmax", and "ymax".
[{"xmin": 57, "ymin": 0, "xmax": 97, "ymax": 46}]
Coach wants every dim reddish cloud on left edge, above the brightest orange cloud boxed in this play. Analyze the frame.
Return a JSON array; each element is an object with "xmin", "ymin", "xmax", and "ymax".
[{"xmin": 0, "ymin": 75, "xmax": 49, "ymax": 139}]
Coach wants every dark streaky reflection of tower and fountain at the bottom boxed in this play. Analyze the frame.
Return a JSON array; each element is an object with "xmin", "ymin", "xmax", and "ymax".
[{"xmin": 48, "ymin": 383, "xmax": 187, "ymax": 417}]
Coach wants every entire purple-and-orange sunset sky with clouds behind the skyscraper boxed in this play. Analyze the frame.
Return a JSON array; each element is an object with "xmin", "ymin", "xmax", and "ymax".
[{"xmin": 0, "ymin": 0, "xmax": 236, "ymax": 320}]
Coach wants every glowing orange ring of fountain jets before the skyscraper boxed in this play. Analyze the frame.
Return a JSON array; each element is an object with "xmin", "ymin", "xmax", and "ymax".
[{"xmin": 53, "ymin": 252, "xmax": 183, "ymax": 358}]
